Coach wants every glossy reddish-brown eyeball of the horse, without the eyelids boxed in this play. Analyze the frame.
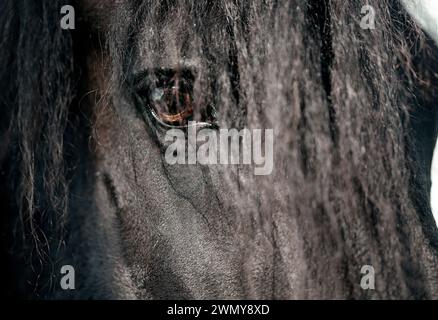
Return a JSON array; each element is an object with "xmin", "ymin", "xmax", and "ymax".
[{"xmin": 149, "ymin": 74, "xmax": 194, "ymax": 125}]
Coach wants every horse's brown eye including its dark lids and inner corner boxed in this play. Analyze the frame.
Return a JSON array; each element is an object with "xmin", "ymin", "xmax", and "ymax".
[{"xmin": 136, "ymin": 69, "xmax": 215, "ymax": 127}]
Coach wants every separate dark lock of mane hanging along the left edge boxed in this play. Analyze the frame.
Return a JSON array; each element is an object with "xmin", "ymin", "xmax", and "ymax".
[{"xmin": 0, "ymin": 0, "xmax": 76, "ymax": 296}]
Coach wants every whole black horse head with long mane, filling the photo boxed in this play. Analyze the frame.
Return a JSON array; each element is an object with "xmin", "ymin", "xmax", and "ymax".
[{"xmin": 0, "ymin": 0, "xmax": 438, "ymax": 299}]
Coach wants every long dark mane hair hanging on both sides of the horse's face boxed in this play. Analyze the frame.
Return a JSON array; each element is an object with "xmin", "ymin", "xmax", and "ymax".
[{"xmin": 0, "ymin": 0, "xmax": 438, "ymax": 297}]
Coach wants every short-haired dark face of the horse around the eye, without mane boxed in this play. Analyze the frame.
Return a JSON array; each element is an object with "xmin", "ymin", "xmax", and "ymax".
[{"xmin": 74, "ymin": 2, "xmax": 273, "ymax": 298}]
